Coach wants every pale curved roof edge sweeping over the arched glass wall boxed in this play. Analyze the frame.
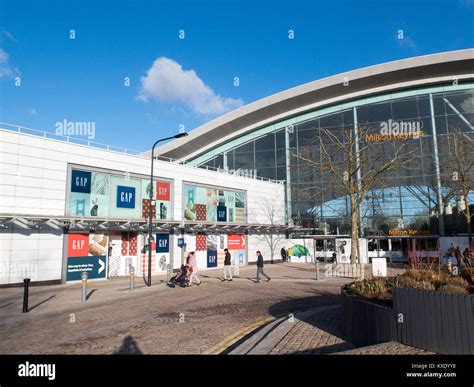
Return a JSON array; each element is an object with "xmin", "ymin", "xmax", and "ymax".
[{"xmin": 155, "ymin": 49, "xmax": 474, "ymax": 160}]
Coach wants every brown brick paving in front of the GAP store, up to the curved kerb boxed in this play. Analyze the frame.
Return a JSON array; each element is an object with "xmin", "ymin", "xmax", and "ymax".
[{"xmin": 0, "ymin": 264, "xmax": 350, "ymax": 354}]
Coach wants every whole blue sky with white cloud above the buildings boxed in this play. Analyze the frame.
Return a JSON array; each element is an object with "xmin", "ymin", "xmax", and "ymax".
[{"xmin": 0, "ymin": 0, "xmax": 474, "ymax": 150}]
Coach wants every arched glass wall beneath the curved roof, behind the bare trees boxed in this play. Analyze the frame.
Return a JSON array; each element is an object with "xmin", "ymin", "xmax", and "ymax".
[{"xmin": 194, "ymin": 84, "xmax": 474, "ymax": 234}]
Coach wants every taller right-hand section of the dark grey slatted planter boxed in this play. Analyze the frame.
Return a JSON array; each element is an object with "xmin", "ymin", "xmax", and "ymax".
[{"xmin": 393, "ymin": 288, "xmax": 474, "ymax": 355}]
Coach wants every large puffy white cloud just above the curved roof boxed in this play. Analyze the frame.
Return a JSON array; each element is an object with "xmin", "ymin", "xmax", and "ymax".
[{"xmin": 138, "ymin": 57, "xmax": 243, "ymax": 115}]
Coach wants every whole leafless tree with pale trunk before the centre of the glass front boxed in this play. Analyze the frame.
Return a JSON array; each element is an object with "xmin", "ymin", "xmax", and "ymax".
[{"xmin": 294, "ymin": 127, "xmax": 417, "ymax": 263}]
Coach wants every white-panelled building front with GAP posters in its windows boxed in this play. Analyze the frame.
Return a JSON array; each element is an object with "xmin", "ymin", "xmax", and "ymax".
[{"xmin": 0, "ymin": 129, "xmax": 285, "ymax": 285}]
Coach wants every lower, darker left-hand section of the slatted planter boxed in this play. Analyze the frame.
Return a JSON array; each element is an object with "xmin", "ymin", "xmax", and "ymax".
[{"xmin": 342, "ymin": 290, "xmax": 397, "ymax": 346}]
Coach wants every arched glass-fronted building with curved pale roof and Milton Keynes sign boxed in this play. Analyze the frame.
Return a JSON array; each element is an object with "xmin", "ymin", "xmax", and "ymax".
[{"xmin": 158, "ymin": 49, "xmax": 474, "ymax": 241}]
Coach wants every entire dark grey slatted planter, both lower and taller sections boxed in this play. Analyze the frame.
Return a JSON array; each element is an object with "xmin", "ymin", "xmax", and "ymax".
[{"xmin": 342, "ymin": 288, "xmax": 474, "ymax": 354}]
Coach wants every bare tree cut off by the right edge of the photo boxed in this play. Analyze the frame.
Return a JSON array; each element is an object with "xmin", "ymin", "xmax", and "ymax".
[{"xmin": 441, "ymin": 129, "xmax": 474, "ymax": 248}]
